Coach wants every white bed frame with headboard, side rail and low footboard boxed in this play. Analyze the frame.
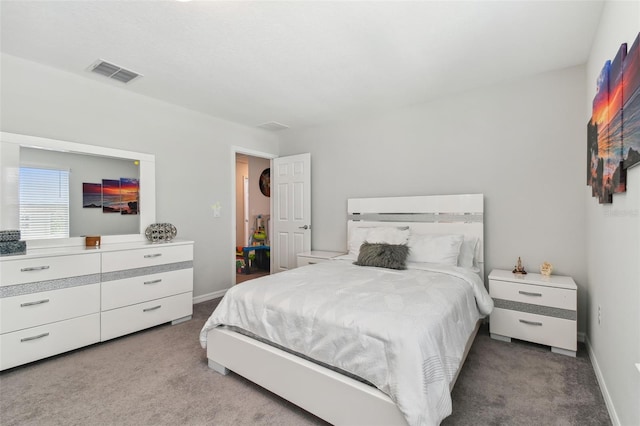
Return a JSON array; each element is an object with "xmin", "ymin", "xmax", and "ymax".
[{"xmin": 207, "ymin": 194, "xmax": 484, "ymax": 426}]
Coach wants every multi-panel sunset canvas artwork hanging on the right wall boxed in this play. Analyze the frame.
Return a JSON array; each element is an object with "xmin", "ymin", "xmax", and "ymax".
[{"xmin": 587, "ymin": 34, "xmax": 640, "ymax": 203}]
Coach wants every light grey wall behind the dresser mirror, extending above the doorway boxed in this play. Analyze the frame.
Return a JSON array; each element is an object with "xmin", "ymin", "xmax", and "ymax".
[{"xmin": 0, "ymin": 54, "xmax": 278, "ymax": 297}]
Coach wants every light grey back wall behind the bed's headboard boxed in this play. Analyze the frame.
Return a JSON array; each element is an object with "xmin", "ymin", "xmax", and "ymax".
[{"xmin": 280, "ymin": 67, "xmax": 586, "ymax": 331}]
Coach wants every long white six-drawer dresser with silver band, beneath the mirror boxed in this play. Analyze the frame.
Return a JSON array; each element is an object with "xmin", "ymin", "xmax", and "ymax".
[{"xmin": 0, "ymin": 241, "xmax": 193, "ymax": 370}]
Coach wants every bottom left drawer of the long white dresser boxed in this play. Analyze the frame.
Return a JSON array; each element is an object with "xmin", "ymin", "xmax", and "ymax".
[{"xmin": 0, "ymin": 313, "xmax": 100, "ymax": 370}]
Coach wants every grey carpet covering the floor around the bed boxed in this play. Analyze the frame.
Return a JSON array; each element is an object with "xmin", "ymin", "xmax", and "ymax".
[{"xmin": 0, "ymin": 300, "xmax": 610, "ymax": 426}]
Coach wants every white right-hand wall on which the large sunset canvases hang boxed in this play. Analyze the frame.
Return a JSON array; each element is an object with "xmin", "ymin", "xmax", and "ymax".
[{"xmin": 583, "ymin": 1, "xmax": 640, "ymax": 425}]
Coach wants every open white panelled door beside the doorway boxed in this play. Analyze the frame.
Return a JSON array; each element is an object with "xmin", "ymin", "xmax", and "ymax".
[{"xmin": 271, "ymin": 153, "xmax": 311, "ymax": 273}]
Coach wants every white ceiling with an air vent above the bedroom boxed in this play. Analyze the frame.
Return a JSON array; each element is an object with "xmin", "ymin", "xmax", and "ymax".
[{"xmin": 0, "ymin": 0, "xmax": 603, "ymax": 128}]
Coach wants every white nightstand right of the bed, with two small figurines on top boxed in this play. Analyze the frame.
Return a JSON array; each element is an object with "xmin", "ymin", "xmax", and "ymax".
[{"xmin": 489, "ymin": 269, "xmax": 578, "ymax": 356}]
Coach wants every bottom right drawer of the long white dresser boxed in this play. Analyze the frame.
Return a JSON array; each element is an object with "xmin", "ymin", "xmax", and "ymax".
[{"xmin": 101, "ymin": 291, "xmax": 193, "ymax": 341}]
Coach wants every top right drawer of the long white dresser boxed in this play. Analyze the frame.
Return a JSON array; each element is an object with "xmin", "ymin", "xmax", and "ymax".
[{"xmin": 102, "ymin": 243, "xmax": 193, "ymax": 272}]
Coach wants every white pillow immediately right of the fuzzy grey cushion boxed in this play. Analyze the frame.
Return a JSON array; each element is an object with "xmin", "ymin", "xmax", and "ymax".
[{"xmin": 407, "ymin": 234, "xmax": 464, "ymax": 266}]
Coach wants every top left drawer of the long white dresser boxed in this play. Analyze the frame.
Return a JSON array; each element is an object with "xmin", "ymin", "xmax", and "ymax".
[{"xmin": 0, "ymin": 253, "xmax": 100, "ymax": 286}]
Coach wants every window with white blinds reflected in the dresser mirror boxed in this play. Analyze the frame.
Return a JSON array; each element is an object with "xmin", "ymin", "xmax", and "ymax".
[{"xmin": 20, "ymin": 167, "xmax": 69, "ymax": 240}]
